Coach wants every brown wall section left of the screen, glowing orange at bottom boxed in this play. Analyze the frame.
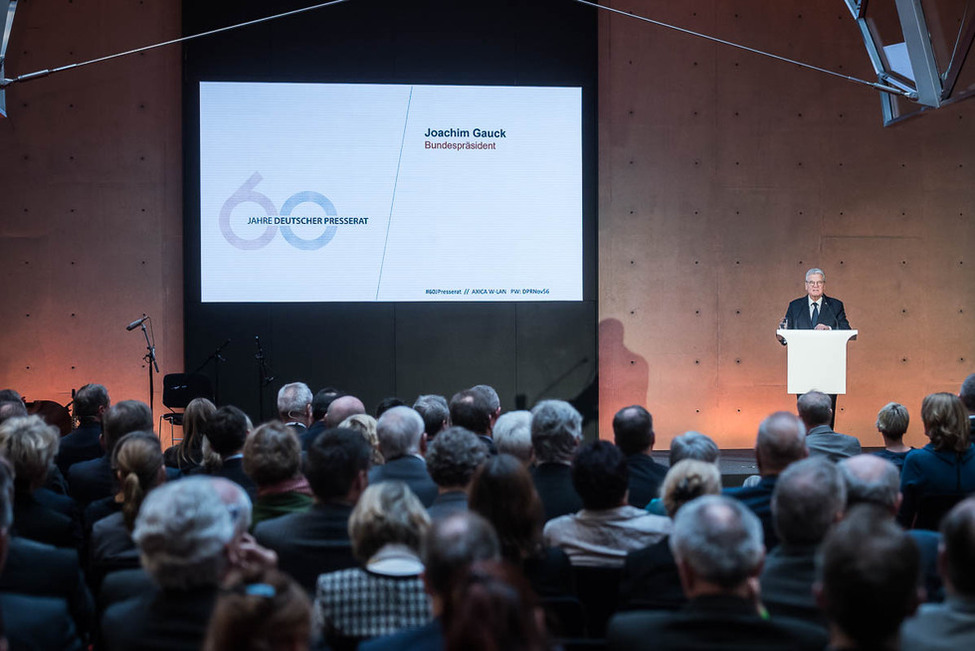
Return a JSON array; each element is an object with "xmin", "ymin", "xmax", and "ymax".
[{"xmin": 0, "ymin": 0, "xmax": 183, "ymax": 418}]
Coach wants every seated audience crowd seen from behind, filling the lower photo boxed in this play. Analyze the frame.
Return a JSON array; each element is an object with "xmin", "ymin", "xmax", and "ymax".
[{"xmin": 0, "ymin": 374, "xmax": 975, "ymax": 651}]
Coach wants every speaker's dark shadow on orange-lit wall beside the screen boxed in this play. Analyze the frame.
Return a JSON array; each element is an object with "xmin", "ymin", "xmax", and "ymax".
[{"xmin": 599, "ymin": 319, "xmax": 650, "ymax": 440}]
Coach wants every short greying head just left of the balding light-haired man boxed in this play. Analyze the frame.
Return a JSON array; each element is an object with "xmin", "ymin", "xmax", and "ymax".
[{"xmin": 772, "ymin": 457, "xmax": 846, "ymax": 545}]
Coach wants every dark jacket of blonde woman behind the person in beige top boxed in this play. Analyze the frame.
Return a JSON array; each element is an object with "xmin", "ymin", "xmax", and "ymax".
[{"xmin": 620, "ymin": 536, "xmax": 687, "ymax": 610}]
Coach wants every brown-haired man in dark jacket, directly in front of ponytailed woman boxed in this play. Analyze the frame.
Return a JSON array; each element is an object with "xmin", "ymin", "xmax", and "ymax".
[{"xmin": 68, "ymin": 400, "xmax": 153, "ymax": 507}]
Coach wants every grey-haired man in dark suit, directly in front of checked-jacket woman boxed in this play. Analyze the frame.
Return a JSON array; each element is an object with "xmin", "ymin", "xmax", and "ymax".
[{"xmin": 369, "ymin": 406, "xmax": 439, "ymax": 507}]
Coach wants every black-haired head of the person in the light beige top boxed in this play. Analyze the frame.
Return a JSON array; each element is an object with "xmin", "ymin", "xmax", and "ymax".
[{"xmin": 572, "ymin": 441, "xmax": 630, "ymax": 510}]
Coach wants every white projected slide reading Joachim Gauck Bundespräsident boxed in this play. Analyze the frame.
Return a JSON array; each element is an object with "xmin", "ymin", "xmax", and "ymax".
[{"xmin": 200, "ymin": 82, "xmax": 582, "ymax": 303}]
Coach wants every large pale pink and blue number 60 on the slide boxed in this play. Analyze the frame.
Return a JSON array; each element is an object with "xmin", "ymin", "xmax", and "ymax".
[{"xmin": 220, "ymin": 172, "xmax": 338, "ymax": 251}]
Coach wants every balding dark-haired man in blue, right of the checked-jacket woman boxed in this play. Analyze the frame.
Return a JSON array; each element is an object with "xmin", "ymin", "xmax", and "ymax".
[{"xmin": 359, "ymin": 511, "xmax": 500, "ymax": 651}]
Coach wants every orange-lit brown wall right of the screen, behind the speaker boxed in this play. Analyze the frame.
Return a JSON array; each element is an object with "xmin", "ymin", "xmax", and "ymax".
[{"xmin": 599, "ymin": 0, "xmax": 975, "ymax": 448}]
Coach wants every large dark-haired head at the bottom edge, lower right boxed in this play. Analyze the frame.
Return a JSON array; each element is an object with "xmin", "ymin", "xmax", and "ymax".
[{"xmin": 819, "ymin": 505, "xmax": 920, "ymax": 649}]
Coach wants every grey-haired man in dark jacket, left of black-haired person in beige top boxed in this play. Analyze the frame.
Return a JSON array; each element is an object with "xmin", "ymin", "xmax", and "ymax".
[{"xmin": 532, "ymin": 400, "xmax": 582, "ymax": 521}]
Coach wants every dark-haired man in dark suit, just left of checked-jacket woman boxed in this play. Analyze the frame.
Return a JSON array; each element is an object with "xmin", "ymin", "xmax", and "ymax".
[{"xmin": 254, "ymin": 429, "xmax": 371, "ymax": 594}]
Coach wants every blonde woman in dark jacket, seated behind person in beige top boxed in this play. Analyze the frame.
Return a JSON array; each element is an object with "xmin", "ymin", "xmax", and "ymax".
[{"xmin": 620, "ymin": 459, "xmax": 721, "ymax": 610}]
